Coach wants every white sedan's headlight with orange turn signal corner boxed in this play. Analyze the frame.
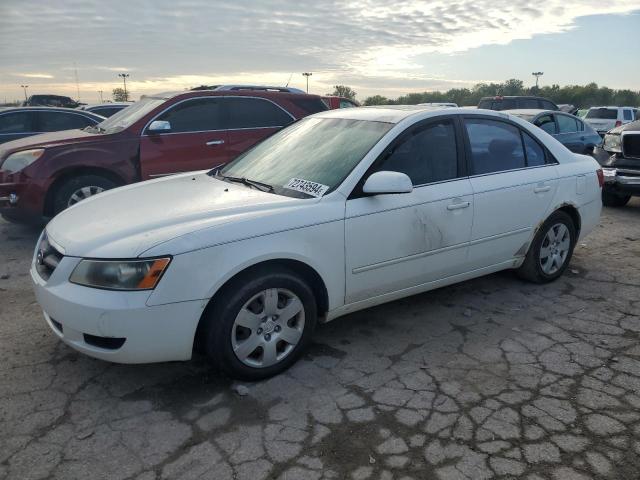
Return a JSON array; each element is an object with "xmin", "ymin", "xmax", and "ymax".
[{"xmin": 69, "ymin": 257, "xmax": 171, "ymax": 290}]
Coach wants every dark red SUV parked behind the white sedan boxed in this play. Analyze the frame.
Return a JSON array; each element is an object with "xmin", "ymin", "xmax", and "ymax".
[{"xmin": 0, "ymin": 90, "xmax": 327, "ymax": 221}]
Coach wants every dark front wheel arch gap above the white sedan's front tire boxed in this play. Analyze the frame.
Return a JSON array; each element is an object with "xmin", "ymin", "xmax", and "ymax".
[{"xmin": 193, "ymin": 258, "xmax": 329, "ymax": 350}]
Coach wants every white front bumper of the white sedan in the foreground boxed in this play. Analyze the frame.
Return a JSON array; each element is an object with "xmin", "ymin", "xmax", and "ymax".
[{"xmin": 31, "ymin": 255, "xmax": 206, "ymax": 363}]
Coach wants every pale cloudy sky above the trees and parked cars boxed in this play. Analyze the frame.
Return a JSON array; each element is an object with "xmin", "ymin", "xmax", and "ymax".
[{"xmin": 0, "ymin": 0, "xmax": 640, "ymax": 102}]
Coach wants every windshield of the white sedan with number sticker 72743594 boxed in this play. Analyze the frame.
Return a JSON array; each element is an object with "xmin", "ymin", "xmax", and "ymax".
[{"xmin": 217, "ymin": 118, "xmax": 393, "ymax": 196}]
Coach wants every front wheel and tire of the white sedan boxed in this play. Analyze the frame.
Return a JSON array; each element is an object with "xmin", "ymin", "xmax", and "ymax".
[{"xmin": 199, "ymin": 267, "xmax": 317, "ymax": 381}]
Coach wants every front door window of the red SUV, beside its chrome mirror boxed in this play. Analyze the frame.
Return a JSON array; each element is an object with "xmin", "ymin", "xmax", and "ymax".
[{"xmin": 156, "ymin": 97, "xmax": 227, "ymax": 133}]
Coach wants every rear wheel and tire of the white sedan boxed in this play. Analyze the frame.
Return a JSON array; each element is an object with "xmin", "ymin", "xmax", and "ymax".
[{"xmin": 516, "ymin": 211, "xmax": 577, "ymax": 283}]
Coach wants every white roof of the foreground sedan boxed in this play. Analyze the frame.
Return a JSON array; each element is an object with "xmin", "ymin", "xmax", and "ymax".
[{"xmin": 313, "ymin": 105, "xmax": 506, "ymax": 123}]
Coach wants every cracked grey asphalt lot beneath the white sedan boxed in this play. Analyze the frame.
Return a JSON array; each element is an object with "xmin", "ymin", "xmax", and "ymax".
[{"xmin": 0, "ymin": 199, "xmax": 640, "ymax": 480}]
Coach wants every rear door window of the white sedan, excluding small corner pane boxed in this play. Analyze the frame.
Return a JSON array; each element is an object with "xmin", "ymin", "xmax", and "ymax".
[{"xmin": 464, "ymin": 118, "xmax": 526, "ymax": 175}]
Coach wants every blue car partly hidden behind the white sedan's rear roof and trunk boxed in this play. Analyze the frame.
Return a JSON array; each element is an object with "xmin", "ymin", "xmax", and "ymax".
[{"xmin": 504, "ymin": 110, "xmax": 602, "ymax": 155}]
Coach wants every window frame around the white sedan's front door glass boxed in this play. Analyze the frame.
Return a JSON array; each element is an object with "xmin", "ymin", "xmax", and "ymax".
[{"xmin": 347, "ymin": 115, "xmax": 468, "ymax": 200}]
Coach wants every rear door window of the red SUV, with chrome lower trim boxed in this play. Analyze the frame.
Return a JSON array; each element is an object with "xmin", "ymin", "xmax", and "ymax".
[{"xmin": 225, "ymin": 97, "xmax": 293, "ymax": 129}]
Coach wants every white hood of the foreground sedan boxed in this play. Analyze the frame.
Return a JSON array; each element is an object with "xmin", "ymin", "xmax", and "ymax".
[{"xmin": 46, "ymin": 172, "xmax": 318, "ymax": 258}]
